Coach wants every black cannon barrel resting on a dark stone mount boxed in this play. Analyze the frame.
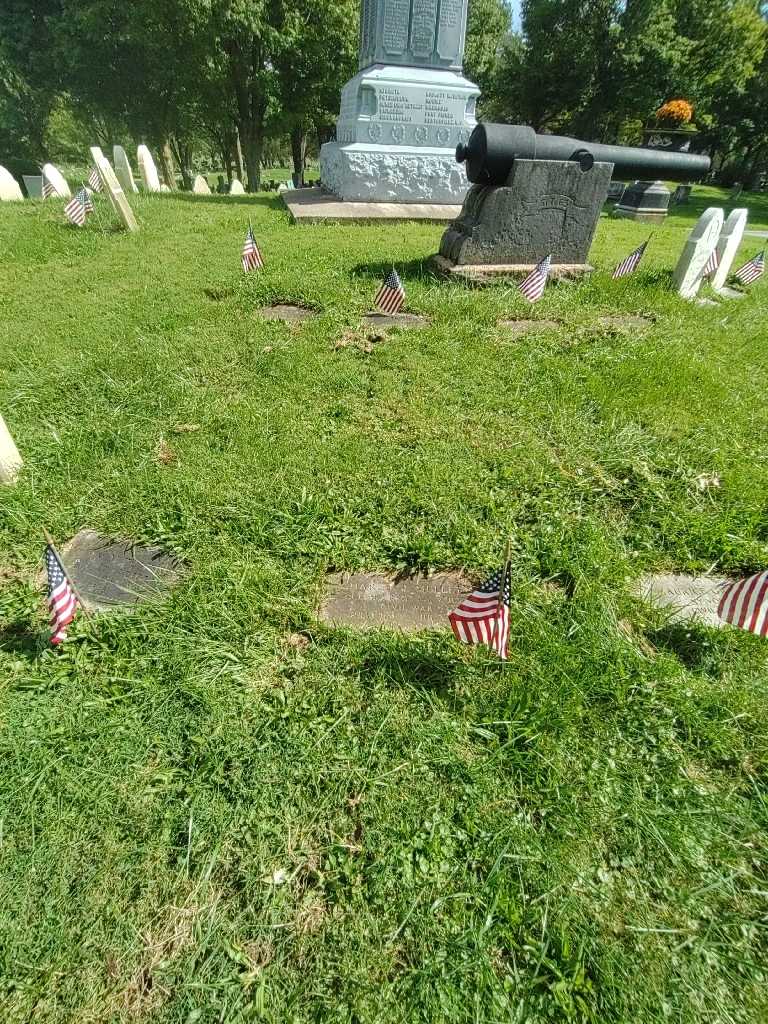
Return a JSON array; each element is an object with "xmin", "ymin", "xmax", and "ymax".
[{"xmin": 456, "ymin": 122, "xmax": 710, "ymax": 185}]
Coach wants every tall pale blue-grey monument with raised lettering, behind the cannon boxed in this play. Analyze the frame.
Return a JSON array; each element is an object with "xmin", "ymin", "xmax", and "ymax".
[{"xmin": 321, "ymin": 0, "xmax": 479, "ymax": 204}]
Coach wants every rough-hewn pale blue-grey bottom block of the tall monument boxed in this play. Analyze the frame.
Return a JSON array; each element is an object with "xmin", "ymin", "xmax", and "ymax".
[{"xmin": 321, "ymin": 142, "xmax": 469, "ymax": 206}]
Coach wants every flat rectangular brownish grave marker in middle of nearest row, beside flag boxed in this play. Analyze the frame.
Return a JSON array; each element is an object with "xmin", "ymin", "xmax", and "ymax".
[{"xmin": 317, "ymin": 572, "xmax": 472, "ymax": 633}]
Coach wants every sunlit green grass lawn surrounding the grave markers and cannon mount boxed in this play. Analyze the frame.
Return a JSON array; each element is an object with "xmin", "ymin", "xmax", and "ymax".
[{"xmin": 0, "ymin": 189, "xmax": 768, "ymax": 1024}]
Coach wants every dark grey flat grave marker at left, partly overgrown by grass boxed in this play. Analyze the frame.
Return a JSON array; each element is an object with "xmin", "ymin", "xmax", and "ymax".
[{"xmin": 61, "ymin": 529, "xmax": 184, "ymax": 611}]
